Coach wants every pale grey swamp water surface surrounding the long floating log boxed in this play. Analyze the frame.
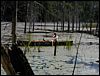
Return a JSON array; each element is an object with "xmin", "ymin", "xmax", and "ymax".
[{"xmin": 1, "ymin": 23, "xmax": 99, "ymax": 75}]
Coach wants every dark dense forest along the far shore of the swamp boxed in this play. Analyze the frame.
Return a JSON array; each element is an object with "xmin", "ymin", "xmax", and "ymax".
[{"xmin": 1, "ymin": 1, "xmax": 99, "ymax": 23}]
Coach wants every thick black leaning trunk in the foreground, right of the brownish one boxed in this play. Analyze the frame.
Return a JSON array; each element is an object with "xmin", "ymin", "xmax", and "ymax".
[{"xmin": 8, "ymin": 45, "xmax": 34, "ymax": 76}]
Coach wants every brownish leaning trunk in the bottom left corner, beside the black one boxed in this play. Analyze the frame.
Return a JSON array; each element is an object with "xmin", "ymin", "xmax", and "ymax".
[{"xmin": 1, "ymin": 46, "xmax": 16, "ymax": 75}]
